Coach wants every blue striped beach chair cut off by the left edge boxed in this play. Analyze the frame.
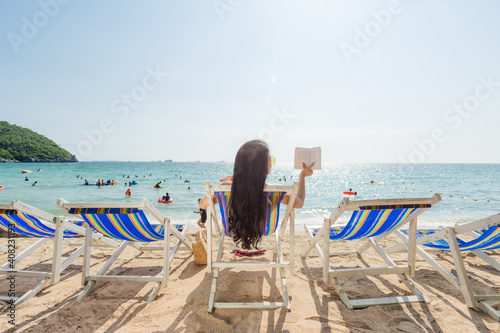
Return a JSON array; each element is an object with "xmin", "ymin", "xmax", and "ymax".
[{"xmin": 0, "ymin": 201, "xmax": 118, "ymax": 305}]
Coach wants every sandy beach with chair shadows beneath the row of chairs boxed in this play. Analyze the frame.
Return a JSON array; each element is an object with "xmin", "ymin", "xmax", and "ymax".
[{"xmin": 0, "ymin": 228, "xmax": 500, "ymax": 332}]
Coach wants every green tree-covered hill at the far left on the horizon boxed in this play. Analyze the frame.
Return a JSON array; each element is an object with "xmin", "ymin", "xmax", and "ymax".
[{"xmin": 0, "ymin": 121, "xmax": 78, "ymax": 162}]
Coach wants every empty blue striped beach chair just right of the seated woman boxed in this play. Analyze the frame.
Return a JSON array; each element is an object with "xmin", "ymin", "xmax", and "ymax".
[{"xmin": 301, "ymin": 194, "xmax": 441, "ymax": 309}]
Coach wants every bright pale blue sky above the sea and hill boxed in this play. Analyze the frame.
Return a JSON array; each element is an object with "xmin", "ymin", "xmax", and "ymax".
[{"xmin": 0, "ymin": 0, "xmax": 500, "ymax": 163}]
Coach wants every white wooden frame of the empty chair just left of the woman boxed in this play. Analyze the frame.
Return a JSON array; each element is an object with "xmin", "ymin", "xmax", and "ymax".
[{"xmin": 57, "ymin": 199, "xmax": 192, "ymax": 305}]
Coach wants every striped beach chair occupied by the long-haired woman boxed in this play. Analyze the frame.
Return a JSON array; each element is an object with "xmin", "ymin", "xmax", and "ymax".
[{"xmin": 205, "ymin": 181, "xmax": 298, "ymax": 313}]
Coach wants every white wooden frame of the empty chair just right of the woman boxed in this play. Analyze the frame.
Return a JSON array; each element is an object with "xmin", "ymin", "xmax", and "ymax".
[{"xmin": 301, "ymin": 194, "xmax": 441, "ymax": 310}]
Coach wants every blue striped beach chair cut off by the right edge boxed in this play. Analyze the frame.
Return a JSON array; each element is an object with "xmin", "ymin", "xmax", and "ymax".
[{"xmin": 388, "ymin": 214, "xmax": 500, "ymax": 321}]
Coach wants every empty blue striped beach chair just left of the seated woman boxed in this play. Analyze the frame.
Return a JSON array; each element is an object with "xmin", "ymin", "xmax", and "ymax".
[{"xmin": 57, "ymin": 199, "xmax": 192, "ymax": 305}]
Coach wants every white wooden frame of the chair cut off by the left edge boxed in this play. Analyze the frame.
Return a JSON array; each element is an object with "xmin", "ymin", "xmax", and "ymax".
[{"xmin": 0, "ymin": 200, "xmax": 119, "ymax": 306}]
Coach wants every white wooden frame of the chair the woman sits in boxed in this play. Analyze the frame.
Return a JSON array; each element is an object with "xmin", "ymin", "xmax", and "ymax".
[{"xmin": 205, "ymin": 181, "xmax": 298, "ymax": 313}]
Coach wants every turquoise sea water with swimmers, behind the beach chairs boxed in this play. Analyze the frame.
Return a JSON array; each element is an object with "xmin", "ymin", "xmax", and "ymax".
[{"xmin": 0, "ymin": 162, "xmax": 500, "ymax": 227}]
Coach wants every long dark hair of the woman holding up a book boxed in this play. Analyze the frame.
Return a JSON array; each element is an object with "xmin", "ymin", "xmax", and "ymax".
[{"xmin": 228, "ymin": 140, "xmax": 269, "ymax": 250}]
